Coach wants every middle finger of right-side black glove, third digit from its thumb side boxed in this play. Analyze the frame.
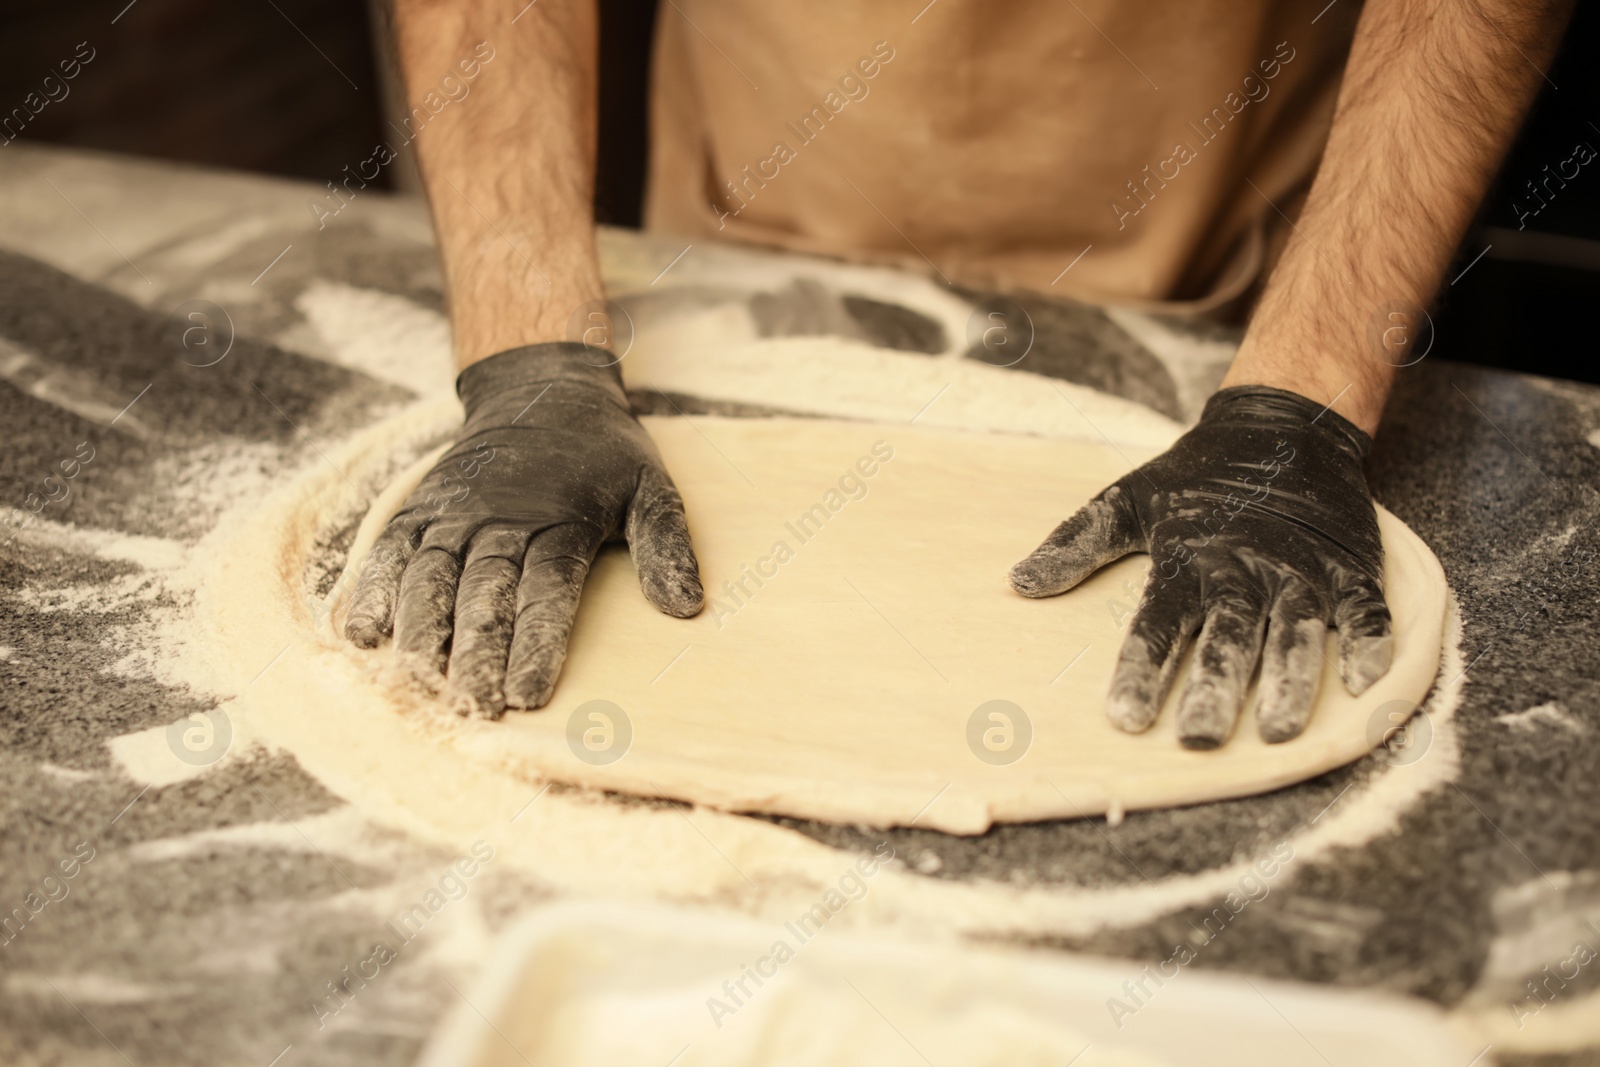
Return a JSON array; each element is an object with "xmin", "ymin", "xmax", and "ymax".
[{"xmin": 1178, "ymin": 577, "xmax": 1267, "ymax": 750}]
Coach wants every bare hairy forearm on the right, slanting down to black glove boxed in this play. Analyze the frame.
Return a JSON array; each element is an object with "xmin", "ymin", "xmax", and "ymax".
[{"xmin": 1222, "ymin": 0, "xmax": 1570, "ymax": 434}]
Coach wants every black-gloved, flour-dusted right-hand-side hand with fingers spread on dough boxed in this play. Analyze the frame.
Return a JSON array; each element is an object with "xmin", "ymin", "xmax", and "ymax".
[{"xmin": 1011, "ymin": 386, "xmax": 1394, "ymax": 749}]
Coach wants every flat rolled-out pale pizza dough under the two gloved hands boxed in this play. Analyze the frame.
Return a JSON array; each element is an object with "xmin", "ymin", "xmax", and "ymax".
[{"xmin": 334, "ymin": 416, "xmax": 1446, "ymax": 833}]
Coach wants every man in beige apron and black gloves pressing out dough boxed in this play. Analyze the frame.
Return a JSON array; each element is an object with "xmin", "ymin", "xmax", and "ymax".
[{"xmin": 347, "ymin": 0, "xmax": 1568, "ymax": 749}]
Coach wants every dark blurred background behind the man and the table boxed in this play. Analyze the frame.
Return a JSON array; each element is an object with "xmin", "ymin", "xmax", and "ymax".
[{"xmin": 0, "ymin": 0, "xmax": 1600, "ymax": 382}]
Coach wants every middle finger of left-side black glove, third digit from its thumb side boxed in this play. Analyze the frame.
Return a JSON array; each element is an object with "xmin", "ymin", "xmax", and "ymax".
[{"xmin": 450, "ymin": 528, "xmax": 528, "ymax": 718}]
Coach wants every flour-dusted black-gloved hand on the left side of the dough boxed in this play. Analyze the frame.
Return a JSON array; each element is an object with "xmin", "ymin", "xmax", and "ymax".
[{"xmin": 344, "ymin": 342, "xmax": 702, "ymax": 718}]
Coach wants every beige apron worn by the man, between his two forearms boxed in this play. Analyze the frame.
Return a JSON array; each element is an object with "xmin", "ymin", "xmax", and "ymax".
[{"xmin": 645, "ymin": 0, "xmax": 1357, "ymax": 310}]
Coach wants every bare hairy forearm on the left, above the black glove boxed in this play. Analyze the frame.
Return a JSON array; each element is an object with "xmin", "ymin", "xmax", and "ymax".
[{"xmin": 395, "ymin": 0, "xmax": 603, "ymax": 366}]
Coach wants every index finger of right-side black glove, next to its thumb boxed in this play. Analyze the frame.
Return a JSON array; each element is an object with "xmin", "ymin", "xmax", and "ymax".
[{"xmin": 1106, "ymin": 568, "xmax": 1200, "ymax": 733}]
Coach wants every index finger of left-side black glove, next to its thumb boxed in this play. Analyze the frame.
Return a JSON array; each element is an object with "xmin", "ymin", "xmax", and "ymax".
[{"xmin": 506, "ymin": 525, "xmax": 605, "ymax": 709}]
